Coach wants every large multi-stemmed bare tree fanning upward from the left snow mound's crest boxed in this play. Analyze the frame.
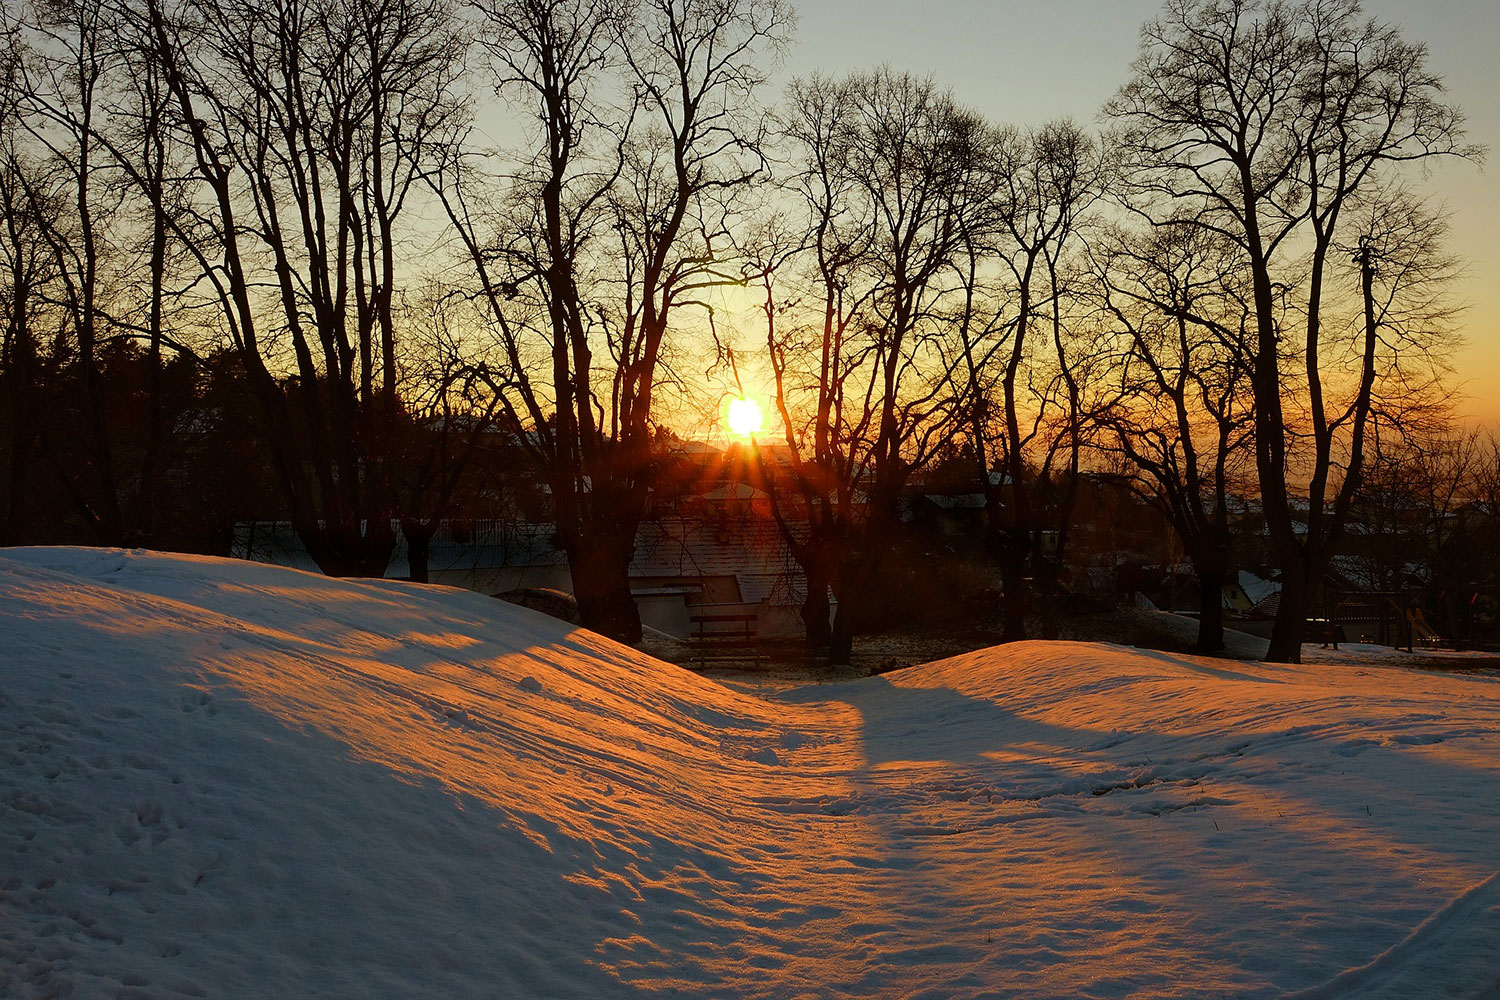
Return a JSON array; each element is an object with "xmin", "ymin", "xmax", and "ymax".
[{"xmin": 117, "ymin": 0, "xmax": 462, "ymax": 576}]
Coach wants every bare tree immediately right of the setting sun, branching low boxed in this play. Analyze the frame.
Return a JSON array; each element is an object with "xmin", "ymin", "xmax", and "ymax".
[{"xmin": 767, "ymin": 70, "xmax": 993, "ymax": 663}]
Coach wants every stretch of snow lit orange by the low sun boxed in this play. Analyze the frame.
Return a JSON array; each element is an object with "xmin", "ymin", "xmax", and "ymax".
[{"xmin": 11, "ymin": 554, "xmax": 1500, "ymax": 996}]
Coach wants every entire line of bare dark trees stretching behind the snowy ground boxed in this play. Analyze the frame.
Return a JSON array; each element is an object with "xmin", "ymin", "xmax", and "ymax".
[{"xmin": 0, "ymin": 0, "xmax": 1482, "ymax": 661}]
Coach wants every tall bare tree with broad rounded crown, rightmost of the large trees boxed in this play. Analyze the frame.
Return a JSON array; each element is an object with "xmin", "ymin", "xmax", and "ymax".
[{"xmin": 1109, "ymin": 0, "xmax": 1473, "ymax": 661}]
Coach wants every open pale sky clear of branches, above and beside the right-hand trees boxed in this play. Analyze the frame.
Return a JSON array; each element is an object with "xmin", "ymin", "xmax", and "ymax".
[{"xmin": 782, "ymin": 0, "xmax": 1500, "ymax": 429}]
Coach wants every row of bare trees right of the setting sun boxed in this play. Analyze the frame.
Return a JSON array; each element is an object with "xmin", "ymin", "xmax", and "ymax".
[{"xmin": 744, "ymin": 1, "xmax": 1476, "ymax": 660}]
